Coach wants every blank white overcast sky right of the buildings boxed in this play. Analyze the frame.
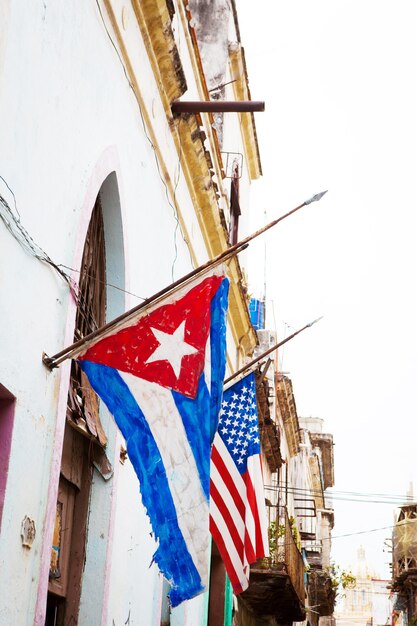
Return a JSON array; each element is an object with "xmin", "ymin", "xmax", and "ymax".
[{"xmin": 238, "ymin": 0, "xmax": 417, "ymax": 577}]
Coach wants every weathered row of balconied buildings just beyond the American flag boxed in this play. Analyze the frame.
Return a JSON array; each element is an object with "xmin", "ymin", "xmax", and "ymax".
[{"xmin": 233, "ymin": 326, "xmax": 335, "ymax": 626}]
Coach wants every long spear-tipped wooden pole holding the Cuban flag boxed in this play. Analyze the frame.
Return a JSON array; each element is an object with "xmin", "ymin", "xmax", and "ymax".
[{"xmin": 42, "ymin": 191, "xmax": 327, "ymax": 369}]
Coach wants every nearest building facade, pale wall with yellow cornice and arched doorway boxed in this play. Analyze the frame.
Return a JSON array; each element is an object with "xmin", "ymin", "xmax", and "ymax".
[{"xmin": 0, "ymin": 0, "xmax": 261, "ymax": 626}]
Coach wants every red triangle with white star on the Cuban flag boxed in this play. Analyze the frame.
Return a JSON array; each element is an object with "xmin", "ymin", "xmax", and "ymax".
[{"xmin": 78, "ymin": 276, "xmax": 223, "ymax": 398}]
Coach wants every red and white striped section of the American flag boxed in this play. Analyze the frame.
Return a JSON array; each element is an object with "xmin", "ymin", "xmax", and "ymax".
[{"xmin": 210, "ymin": 433, "xmax": 269, "ymax": 594}]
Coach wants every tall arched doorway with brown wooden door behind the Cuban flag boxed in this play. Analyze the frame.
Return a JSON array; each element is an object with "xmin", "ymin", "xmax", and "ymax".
[{"xmin": 45, "ymin": 172, "xmax": 125, "ymax": 626}]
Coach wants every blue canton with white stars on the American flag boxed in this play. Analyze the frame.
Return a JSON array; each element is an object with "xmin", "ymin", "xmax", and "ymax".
[{"xmin": 218, "ymin": 373, "xmax": 261, "ymax": 474}]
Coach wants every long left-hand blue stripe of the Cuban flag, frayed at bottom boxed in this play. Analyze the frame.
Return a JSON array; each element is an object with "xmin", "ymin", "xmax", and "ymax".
[{"xmin": 79, "ymin": 361, "xmax": 204, "ymax": 606}]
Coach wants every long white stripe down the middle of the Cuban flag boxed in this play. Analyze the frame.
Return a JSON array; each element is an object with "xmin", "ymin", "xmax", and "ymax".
[{"xmin": 119, "ymin": 371, "xmax": 209, "ymax": 586}]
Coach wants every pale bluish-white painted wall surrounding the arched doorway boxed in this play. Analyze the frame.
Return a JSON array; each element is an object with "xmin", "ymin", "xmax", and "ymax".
[{"xmin": 0, "ymin": 0, "xmax": 255, "ymax": 626}]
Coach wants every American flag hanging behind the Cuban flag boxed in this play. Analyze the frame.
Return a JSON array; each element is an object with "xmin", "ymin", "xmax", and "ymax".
[{"xmin": 210, "ymin": 373, "xmax": 269, "ymax": 594}]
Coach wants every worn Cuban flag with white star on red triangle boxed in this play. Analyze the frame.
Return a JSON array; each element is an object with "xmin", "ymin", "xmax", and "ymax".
[{"xmin": 77, "ymin": 268, "xmax": 229, "ymax": 606}]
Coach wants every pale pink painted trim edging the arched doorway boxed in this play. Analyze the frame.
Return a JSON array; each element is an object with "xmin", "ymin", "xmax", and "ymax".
[{"xmin": 34, "ymin": 146, "xmax": 123, "ymax": 626}]
